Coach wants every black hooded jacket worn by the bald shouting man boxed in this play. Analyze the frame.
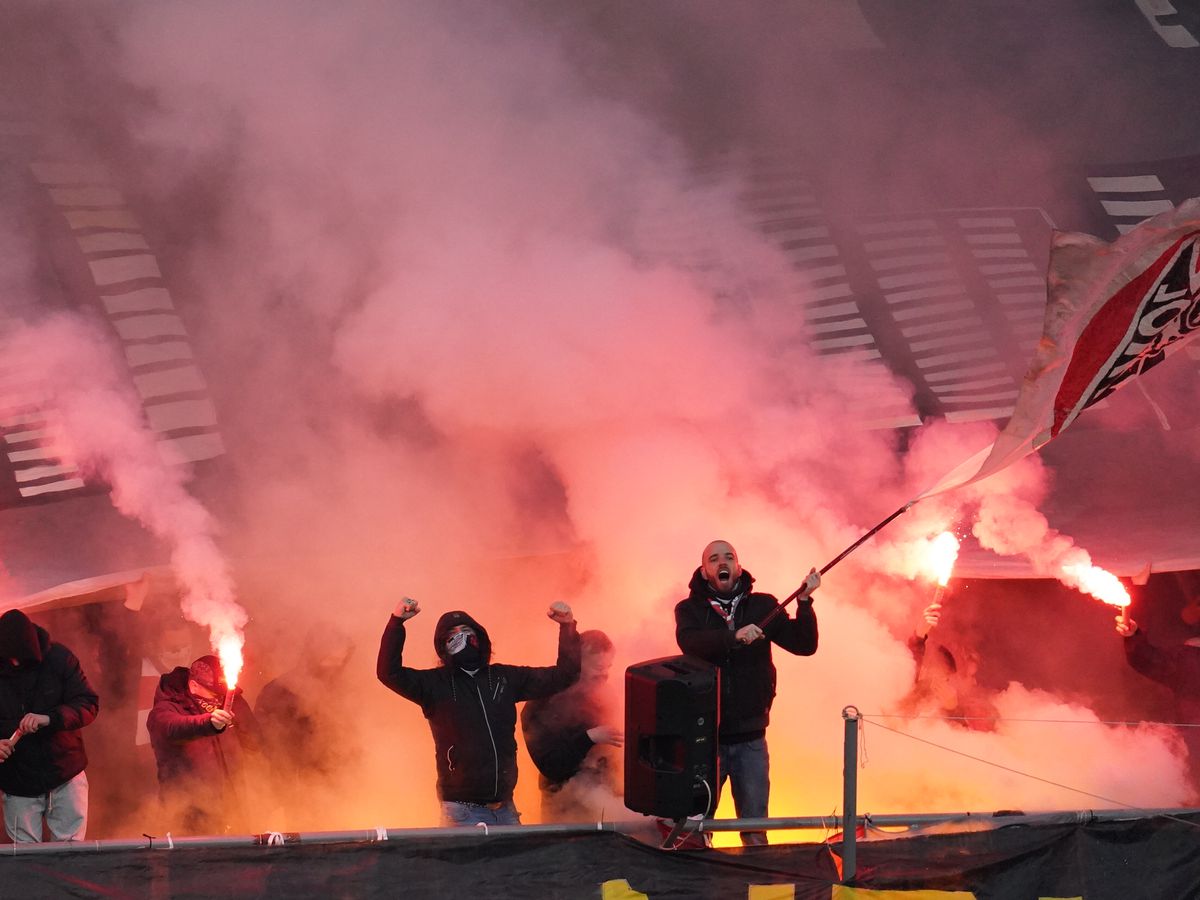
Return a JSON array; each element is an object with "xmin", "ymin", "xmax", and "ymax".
[{"xmin": 676, "ymin": 569, "xmax": 817, "ymax": 744}]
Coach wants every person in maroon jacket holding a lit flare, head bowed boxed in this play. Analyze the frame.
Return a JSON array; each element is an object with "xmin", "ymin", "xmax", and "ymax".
[{"xmin": 146, "ymin": 656, "xmax": 259, "ymax": 834}]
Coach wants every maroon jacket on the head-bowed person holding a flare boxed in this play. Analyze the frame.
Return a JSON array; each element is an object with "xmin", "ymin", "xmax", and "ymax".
[{"xmin": 146, "ymin": 666, "xmax": 258, "ymax": 830}]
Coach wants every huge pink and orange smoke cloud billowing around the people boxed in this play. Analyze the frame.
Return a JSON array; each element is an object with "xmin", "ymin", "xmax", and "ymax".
[{"xmin": 0, "ymin": 1, "xmax": 1186, "ymax": 844}]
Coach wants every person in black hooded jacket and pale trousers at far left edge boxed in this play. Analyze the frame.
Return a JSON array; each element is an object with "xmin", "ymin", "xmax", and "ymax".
[{"xmin": 0, "ymin": 610, "xmax": 100, "ymax": 842}]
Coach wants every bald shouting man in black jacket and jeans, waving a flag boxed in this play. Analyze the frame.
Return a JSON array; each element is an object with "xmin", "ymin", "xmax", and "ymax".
[{"xmin": 676, "ymin": 540, "xmax": 821, "ymax": 845}]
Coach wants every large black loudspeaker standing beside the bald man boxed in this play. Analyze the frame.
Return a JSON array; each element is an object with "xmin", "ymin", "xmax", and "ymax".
[{"xmin": 625, "ymin": 656, "xmax": 721, "ymax": 818}]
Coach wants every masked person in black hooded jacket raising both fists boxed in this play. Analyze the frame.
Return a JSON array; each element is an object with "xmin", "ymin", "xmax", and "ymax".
[{"xmin": 376, "ymin": 598, "xmax": 580, "ymax": 826}]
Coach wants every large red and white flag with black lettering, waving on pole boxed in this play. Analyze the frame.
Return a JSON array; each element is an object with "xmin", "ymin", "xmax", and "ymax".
[{"xmin": 917, "ymin": 198, "xmax": 1200, "ymax": 499}]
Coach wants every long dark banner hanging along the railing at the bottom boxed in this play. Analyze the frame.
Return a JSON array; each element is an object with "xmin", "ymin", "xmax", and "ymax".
[{"xmin": 7, "ymin": 817, "xmax": 1200, "ymax": 900}]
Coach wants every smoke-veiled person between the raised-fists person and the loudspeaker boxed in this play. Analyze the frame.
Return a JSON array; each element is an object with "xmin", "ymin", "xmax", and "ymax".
[{"xmin": 521, "ymin": 630, "xmax": 625, "ymax": 822}]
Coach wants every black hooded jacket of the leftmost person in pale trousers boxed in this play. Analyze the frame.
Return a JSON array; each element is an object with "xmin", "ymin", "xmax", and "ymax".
[{"xmin": 0, "ymin": 610, "xmax": 100, "ymax": 797}]
